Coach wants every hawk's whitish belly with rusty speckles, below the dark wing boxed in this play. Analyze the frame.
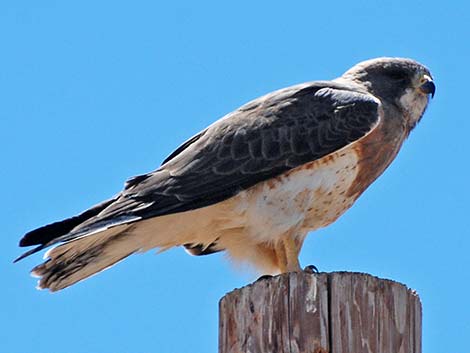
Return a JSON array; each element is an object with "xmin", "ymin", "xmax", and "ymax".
[{"xmin": 237, "ymin": 148, "xmax": 358, "ymax": 242}]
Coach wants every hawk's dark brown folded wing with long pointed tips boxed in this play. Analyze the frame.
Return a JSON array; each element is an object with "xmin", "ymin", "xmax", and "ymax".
[{"xmin": 20, "ymin": 82, "xmax": 380, "ymax": 270}]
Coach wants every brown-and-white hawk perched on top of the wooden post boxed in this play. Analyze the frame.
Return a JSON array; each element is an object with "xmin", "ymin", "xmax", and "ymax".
[{"xmin": 17, "ymin": 58, "xmax": 435, "ymax": 291}]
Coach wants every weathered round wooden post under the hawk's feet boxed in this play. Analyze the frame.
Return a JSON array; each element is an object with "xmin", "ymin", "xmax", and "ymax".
[{"xmin": 219, "ymin": 272, "xmax": 421, "ymax": 353}]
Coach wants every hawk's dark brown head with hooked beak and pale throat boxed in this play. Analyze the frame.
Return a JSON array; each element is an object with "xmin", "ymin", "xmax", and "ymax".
[{"xmin": 341, "ymin": 58, "xmax": 436, "ymax": 130}]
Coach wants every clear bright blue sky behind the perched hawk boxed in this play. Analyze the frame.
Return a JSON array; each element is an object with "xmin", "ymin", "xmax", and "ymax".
[{"xmin": 0, "ymin": 0, "xmax": 470, "ymax": 353}]
